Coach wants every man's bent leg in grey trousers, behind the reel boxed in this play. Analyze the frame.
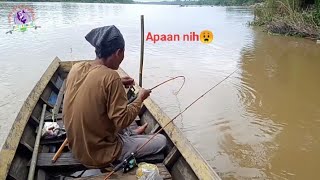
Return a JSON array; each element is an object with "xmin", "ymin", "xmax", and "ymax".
[{"xmin": 118, "ymin": 134, "xmax": 167, "ymax": 161}]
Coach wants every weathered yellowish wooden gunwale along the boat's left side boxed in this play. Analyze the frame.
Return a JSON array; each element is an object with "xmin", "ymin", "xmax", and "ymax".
[{"xmin": 0, "ymin": 58, "xmax": 60, "ymax": 179}]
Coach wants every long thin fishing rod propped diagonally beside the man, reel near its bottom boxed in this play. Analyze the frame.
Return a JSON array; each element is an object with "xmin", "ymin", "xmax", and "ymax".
[{"xmin": 104, "ymin": 69, "xmax": 238, "ymax": 180}]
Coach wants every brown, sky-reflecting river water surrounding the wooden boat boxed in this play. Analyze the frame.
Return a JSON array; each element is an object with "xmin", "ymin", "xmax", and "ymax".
[{"xmin": 0, "ymin": 3, "xmax": 320, "ymax": 179}]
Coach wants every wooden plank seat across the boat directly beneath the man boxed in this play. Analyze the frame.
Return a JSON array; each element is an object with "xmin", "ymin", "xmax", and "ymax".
[{"xmin": 28, "ymin": 152, "xmax": 164, "ymax": 169}]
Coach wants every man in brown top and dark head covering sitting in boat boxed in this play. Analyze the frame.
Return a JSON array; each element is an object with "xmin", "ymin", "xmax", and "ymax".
[{"xmin": 63, "ymin": 25, "xmax": 166, "ymax": 168}]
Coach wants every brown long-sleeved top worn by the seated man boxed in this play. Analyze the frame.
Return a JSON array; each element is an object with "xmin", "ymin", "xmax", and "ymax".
[{"xmin": 63, "ymin": 62, "xmax": 142, "ymax": 168}]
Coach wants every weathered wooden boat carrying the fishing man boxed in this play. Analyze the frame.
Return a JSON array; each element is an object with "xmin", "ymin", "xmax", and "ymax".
[{"xmin": 0, "ymin": 58, "xmax": 220, "ymax": 180}]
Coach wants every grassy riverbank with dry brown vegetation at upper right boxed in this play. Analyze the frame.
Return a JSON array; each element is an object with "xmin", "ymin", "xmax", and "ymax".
[{"xmin": 250, "ymin": 1, "xmax": 320, "ymax": 40}]
